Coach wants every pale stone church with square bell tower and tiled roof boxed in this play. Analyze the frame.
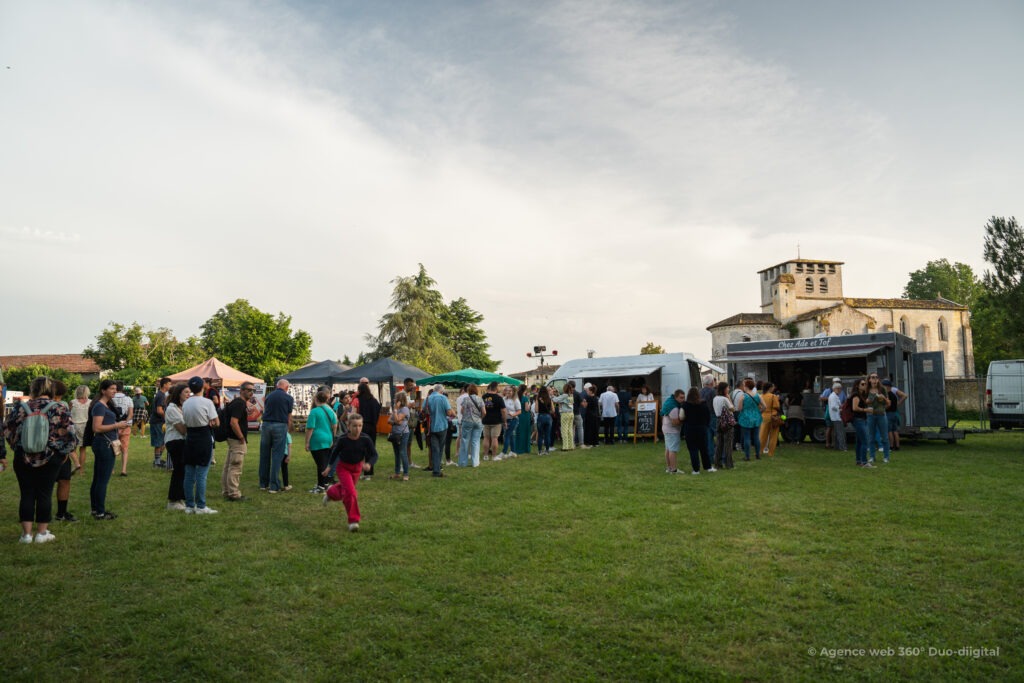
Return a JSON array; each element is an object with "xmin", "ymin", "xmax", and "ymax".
[{"xmin": 708, "ymin": 258, "xmax": 974, "ymax": 378}]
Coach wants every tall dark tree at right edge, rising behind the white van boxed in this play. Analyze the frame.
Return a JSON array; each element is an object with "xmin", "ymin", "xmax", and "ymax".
[{"xmin": 971, "ymin": 216, "xmax": 1024, "ymax": 372}]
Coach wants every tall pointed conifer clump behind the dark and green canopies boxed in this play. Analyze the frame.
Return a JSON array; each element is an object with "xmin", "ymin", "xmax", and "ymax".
[{"xmin": 359, "ymin": 263, "xmax": 498, "ymax": 373}]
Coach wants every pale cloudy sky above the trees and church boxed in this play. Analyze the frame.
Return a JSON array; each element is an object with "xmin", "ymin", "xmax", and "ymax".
[{"xmin": 0, "ymin": 0, "xmax": 1024, "ymax": 372}]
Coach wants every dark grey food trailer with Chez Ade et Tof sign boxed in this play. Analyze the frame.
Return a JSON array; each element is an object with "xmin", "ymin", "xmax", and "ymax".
[{"xmin": 722, "ymin": 332, "xmax": 965, "ymax": 443}]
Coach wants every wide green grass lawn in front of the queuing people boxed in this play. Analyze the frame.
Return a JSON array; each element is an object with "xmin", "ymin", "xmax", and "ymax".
[{"xmin": 0, "ymin": 432, "xmax": 1024, "ymax": 681}]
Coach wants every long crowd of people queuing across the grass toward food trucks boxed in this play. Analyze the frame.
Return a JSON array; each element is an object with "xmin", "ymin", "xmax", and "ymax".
[{"xmin": 0, "ymin": 373, "xmax": 906, "ymax": 544}]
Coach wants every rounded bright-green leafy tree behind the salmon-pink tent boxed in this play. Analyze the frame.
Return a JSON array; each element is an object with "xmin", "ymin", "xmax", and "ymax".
[{"xmin": 200, "ymin": 299, "xmax": 312, "ymax": 383}]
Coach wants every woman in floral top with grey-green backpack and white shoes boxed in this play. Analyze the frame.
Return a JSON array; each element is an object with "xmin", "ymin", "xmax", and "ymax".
[{"xmin": 3, "ymin": 377, "xmax": 77, "ymax": 543}]
